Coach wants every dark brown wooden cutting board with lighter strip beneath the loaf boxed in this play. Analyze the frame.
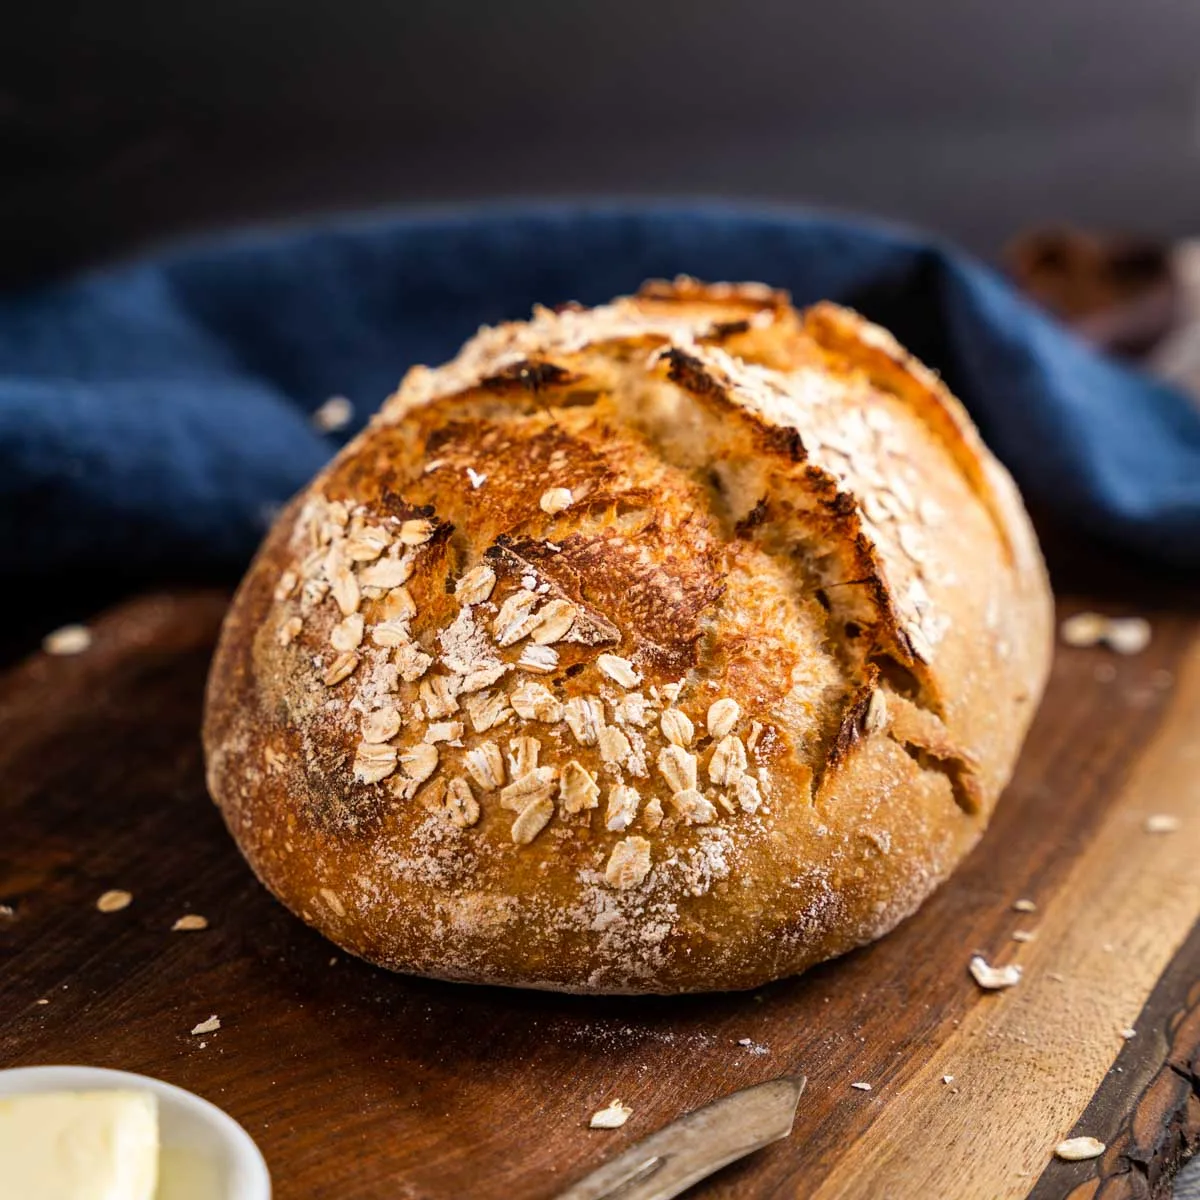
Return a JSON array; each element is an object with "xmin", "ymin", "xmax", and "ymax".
[{"xmin": 0, "ymin": 593, "xmax": 1200, "ymax": 1200}]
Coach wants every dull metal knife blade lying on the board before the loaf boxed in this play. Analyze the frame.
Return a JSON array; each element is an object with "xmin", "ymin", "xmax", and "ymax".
[{"xmin": 558, "ymin": 1075, "xmax": 808, "ymax": 1200}]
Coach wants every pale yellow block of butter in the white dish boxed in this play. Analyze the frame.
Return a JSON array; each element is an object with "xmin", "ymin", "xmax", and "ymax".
[{"xmin": 0, "ymin": 1092, "xmax": 158, "ymax": 1200}]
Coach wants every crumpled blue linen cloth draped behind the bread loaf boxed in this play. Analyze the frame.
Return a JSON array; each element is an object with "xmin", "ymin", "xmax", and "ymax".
[{"xmin": 0, "ymin": 205, "xmax": 1200, "ymax": 577}]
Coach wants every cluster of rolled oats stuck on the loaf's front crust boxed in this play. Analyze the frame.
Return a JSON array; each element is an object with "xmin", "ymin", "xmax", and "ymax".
[{"xmin": 275, "ymin": 488, "xmax": 763, "ymax": 889}]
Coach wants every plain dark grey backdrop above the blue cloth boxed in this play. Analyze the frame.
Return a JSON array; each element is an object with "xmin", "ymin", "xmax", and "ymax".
[{"xmin": 0, "ymin": 0, "xmax": 1200, "ymax": 280}]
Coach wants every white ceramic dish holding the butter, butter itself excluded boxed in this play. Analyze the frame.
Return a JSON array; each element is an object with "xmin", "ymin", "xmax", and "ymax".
[{"xmin": 0, "ymin": 1067, "xmax": 271, "ymax": 1200}]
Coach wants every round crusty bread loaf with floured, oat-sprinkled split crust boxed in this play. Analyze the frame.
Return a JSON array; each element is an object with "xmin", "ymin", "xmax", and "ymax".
[{"xmin": 204, "ymin": 278, "xmax": 1051, "ymax": 992}]
